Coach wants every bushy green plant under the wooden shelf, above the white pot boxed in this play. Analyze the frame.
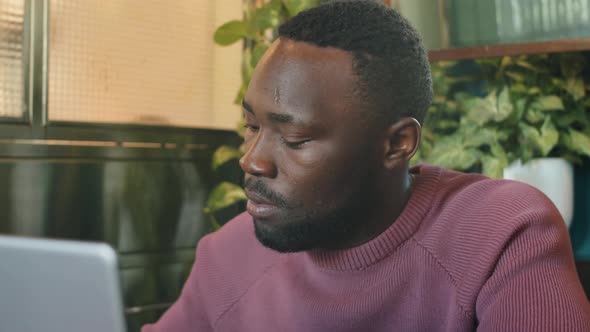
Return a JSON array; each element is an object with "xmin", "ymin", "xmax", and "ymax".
[{"xmin": 416, "ymin": 53, "xmax": 590, "ymax": 177}]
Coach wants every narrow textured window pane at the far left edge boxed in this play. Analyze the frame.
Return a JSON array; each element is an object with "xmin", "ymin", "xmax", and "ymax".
[{"xmin": 0, "ymin": 0, "xmax": 24, "ymax": 118}]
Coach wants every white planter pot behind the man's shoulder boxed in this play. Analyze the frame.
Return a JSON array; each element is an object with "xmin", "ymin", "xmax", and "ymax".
[{"xmin": 504, "ymin": 158, "xmax": 574, "ymax": 227}]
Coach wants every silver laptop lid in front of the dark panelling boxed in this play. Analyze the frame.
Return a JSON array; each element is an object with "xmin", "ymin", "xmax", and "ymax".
[{"xmin": 0, "ymin": 236, "xmax": 125, "ymax": 332}]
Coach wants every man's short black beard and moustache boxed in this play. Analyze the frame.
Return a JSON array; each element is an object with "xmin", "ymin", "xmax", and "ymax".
[{"xmin": 246, "ymin": 176, "xmax": 372, "ymax": 253}]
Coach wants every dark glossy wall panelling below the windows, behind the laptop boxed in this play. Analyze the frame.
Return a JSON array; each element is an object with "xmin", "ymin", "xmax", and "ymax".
[{"xmin": 0, "ymin": 134, "xmax": 239, "ymax": 331}]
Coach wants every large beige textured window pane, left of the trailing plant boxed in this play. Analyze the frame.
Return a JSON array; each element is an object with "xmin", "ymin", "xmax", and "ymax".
[{"xmin": 48, "ymin": 0, "xmax": 224, "ymax": 127}]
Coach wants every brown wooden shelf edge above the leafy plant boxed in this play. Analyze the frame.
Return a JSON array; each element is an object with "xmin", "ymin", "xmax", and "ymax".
[{"xmin": 428, "ymin": 38, "xmax": 590, "ymax": 62}]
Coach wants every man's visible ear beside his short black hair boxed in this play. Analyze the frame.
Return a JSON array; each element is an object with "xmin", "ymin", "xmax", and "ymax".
[{"xmin": 384, "ymin": 117, "xmax": 422, "ymax": 169}]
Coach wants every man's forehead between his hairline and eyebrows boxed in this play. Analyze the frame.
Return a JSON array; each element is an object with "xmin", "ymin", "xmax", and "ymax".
[{"xmin": 245, "ymin": 39, "xmax": 364, "ymax": 122}]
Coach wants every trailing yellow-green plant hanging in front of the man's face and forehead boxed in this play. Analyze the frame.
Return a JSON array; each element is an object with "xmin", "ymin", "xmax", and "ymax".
[{"xmin": 204, "ymin": 0, "xmax": 320, "ymax": 230}]
